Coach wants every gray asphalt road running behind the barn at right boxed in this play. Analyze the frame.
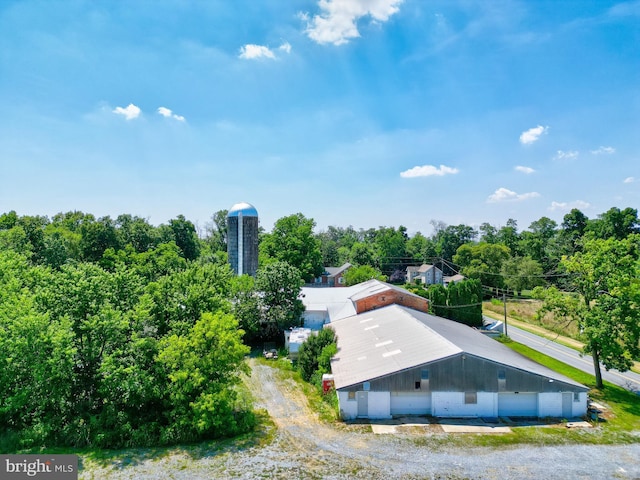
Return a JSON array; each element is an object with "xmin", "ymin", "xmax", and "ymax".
[{"xmin": 507, "ymin": 325, "xmax": 640, "ymax": 394}]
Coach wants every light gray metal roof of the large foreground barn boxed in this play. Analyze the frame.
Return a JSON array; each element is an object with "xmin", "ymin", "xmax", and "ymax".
[{"xmin": 330, "ymin": 305, "xmax": 587, "ymax": 390}]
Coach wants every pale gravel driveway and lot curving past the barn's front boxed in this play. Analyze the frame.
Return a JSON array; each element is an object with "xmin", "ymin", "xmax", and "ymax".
[{"xmin": 80, "ymin": 361, "xmax": 640, "ymax": 480}]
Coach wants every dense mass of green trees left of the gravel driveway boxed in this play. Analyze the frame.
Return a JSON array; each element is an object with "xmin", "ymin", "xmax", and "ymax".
[{"xmin": 0, "ymin": 212, "xmax": 255, "ymax": 449}]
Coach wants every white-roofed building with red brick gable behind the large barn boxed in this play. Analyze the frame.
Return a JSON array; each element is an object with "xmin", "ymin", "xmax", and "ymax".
[{"xmin": 300, "ymin": 280, "xmax": 429, "ymax": 330}]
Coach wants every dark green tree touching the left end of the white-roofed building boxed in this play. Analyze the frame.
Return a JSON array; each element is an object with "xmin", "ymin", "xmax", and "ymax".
[{"xmin": 255, "ymin": 262, "xmax": 304, "ymax": 340}]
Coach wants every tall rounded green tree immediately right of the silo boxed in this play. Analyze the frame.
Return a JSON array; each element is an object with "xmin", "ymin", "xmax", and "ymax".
[{"xmin": 259, "ymin": 213, "xmax": 324, "ymax": 282}]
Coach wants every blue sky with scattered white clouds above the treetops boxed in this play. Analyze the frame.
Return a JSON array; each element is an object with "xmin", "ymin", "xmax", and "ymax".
[{"xmin": 0, "ymin": 0, "xmax": 640, "ymax": 234}]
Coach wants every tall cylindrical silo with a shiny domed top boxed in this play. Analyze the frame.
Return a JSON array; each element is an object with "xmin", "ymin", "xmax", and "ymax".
[{"xmin": 227, "ymin": 202, "xmax": 258, "ymax": 276}]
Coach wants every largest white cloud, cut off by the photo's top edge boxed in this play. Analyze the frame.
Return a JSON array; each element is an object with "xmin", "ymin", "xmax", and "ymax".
[{"xmin": 302, "ymin": 0, "xmax": 403, "ymax": 45}]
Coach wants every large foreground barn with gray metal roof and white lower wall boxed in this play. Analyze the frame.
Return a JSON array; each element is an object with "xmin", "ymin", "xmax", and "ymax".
[{"xmin": 327, "ymin": 305, "xmax": 588, "ymax": 419}]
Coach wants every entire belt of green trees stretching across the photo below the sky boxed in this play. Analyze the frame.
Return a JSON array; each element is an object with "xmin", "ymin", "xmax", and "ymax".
[{"xmin": 0, "ymin": 208, "xmax": 640, "ymax": 448}]
